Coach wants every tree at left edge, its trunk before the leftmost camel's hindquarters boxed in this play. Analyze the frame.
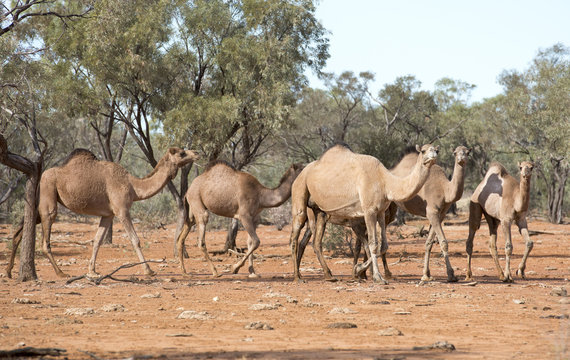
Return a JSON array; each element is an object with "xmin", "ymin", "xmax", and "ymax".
[{"xmin": 0, "ymin": 0, "xmax": 91, "ymax": 281}]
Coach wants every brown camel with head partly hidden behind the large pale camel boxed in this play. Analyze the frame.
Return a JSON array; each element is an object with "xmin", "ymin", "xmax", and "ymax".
[{"xmin": 176, "ymin": 161, "xmax": 303, "ymax": 277}]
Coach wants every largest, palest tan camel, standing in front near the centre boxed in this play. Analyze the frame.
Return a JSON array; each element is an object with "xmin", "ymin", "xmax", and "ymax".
[{"xmin": 290, "ymin": 144, "xmax": 437, "ymax": 283}]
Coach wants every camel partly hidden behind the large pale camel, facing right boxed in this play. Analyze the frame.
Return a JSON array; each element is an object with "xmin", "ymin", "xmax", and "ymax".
[{"xmin": 382, "ymin": 146, "xmax": 470, "ymax": 282}]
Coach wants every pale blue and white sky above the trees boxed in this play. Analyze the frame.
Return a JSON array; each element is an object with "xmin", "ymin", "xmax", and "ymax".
[{"xmin": 307, "ymin": 0, "xmax": 570, "ymax": 101}]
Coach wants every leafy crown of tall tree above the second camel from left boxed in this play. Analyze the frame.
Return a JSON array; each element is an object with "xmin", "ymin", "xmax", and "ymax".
[{"xmin": 163, "ymin": 0, "xmax": 328, "ymax": 250}]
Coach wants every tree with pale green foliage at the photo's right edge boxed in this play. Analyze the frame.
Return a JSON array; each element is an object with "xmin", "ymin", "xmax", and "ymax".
[{"xmin": 495, "ymin": 44, "xmax": 570, "ymax": 223}]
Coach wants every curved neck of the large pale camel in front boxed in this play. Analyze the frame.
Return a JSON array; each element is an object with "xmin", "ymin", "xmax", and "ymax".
[{"xmin": 384, "ymin": 157, "xmax": 429, "ymax": 202}]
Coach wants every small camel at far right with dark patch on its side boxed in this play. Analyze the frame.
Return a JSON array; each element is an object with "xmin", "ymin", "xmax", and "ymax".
[{"xmin": 466, "ymin": 161, "xmax": 534, "ymax": 282}]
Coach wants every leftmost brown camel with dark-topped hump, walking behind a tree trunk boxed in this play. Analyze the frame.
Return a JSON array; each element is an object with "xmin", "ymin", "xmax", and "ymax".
[{"xmin": 6, "ymin": 147, "xmax": 198, "ymax": 277}]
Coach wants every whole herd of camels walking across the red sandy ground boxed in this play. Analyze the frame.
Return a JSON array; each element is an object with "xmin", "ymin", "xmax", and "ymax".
[{"xmin": 6, "ymin": 144, "xmax": 533, "ymax": 283}]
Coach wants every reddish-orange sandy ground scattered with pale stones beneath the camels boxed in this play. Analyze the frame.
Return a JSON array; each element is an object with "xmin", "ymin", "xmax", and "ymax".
[{"xmin": 0, "ymin": 216, "xmax": 570, "ymax": 359}]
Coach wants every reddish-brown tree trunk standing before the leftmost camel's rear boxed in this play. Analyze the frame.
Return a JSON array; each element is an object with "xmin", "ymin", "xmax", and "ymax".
[{"xmin": 18, "ymin": 170, "xmax": 40, "ymax": 282}]
